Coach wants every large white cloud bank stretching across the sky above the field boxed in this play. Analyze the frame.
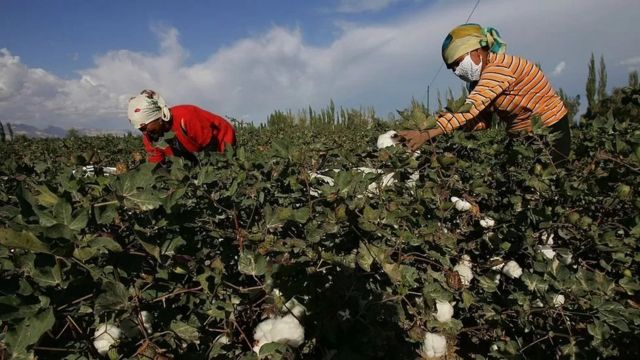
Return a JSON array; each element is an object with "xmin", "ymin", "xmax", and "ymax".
[{"xmin": 0, "ymin": 0, "xmax": 640, "ymax": 128}]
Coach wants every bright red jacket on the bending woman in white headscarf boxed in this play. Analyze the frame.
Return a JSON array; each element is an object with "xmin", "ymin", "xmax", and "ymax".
[{"xmin": 142, "ymin": 105, "xmax": 236, "ymax": 163}]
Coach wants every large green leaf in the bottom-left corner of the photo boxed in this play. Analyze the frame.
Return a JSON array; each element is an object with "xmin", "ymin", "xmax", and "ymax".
[{"xmin": 4, "ymin": 308, "xmax": 55, "ymax": 359}]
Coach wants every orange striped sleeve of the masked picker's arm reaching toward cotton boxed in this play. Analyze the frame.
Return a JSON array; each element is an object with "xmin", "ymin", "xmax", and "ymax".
[{"xmin": 437, "ymin": 64, "xmax": 516, "ymax": 133}]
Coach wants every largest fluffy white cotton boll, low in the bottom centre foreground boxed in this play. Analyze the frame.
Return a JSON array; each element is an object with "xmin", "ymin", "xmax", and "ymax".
[{"xmin": 253, "ymin": 314, "xmax": 304, "ymax": 354}]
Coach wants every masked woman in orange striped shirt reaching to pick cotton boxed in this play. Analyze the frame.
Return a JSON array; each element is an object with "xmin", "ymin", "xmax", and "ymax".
[{"xmin": 400, "ymin": 24, "xmax": 571, "ymax": 163}]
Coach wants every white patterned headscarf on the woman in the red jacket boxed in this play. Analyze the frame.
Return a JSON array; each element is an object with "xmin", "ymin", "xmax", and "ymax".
[{"xmin": 127, "ymin": 90, "xmax": 171, "ymax": 129}]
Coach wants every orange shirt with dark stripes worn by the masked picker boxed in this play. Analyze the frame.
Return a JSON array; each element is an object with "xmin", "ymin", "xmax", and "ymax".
[{"xmin": 438, "ymin": 53, "xmax": 567, "ymax": 132}]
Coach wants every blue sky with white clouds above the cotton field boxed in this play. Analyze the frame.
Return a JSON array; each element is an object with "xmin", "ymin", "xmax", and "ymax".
[{"xmin": 0, "ymin": 0, "xmax": 640, "ymax": 130}]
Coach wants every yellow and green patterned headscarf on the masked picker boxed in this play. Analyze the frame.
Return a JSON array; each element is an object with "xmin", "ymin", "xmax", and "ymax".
[{"xmin": 442, "ymin": 24, "xmax": 507, "ymax": 65}]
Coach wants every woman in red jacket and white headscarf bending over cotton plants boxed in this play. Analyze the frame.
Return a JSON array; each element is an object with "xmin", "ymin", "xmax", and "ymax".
[{"xmin": 128, "ymin": 90, "xmax": 236, "ymax": 163}]
